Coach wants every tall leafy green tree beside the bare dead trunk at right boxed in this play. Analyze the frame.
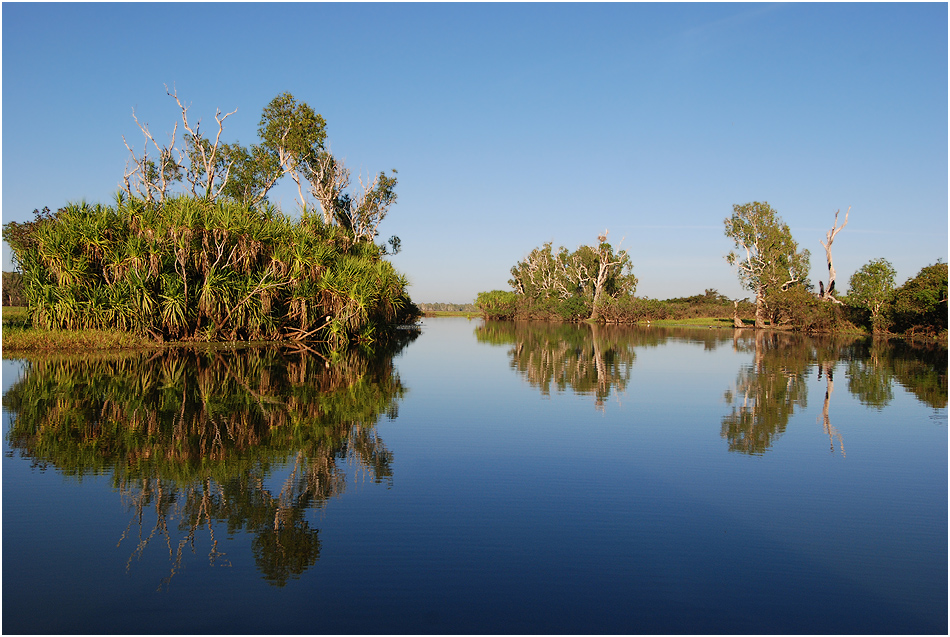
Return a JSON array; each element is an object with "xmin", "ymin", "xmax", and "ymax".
[{"xmin": 723, "ymin": 201, "xmax": 810, "ymax": 328}]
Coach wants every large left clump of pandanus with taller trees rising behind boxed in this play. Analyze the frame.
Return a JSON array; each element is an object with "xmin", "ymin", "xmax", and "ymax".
[{"xmin": 3, "ymin": 88, "xmax": 420, "ymax": 347}]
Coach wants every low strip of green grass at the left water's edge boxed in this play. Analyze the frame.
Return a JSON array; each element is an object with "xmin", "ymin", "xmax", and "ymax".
[{"xmin": 2, "ymin": 307, "xmax": 155, "ymax": 350}]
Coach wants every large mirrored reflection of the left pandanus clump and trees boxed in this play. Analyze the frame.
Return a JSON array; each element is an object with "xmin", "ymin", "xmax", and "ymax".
[{"xmin": 4, "ymin": 332, "xmax": 417, "ymax": 586}]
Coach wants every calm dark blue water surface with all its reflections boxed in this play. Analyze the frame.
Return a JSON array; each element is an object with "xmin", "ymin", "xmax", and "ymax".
[{"xmin": 3, "ymin": 319, "xmax": 948, "ymax": 634}]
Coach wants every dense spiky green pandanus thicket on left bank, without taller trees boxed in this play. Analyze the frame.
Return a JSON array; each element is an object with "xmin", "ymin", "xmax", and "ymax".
[{"xmin": 6, "ymin": 191, "xmax": 416, "ymax": 346}]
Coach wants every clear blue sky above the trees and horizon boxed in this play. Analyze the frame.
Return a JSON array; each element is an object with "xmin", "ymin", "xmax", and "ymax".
[{"xmin": 2, "ymin": 3, "xmax": 948, "ymax": 302}]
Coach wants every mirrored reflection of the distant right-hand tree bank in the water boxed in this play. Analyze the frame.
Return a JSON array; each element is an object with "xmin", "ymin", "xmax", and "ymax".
[{"xmin": 475, "ymin": 321, "xmax": 947, "ymax": 457}]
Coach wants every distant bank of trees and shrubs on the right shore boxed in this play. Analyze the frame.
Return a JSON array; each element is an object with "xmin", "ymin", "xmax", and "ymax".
[{"xmin": 475, "ymin": 201, "xmax": 947, "ymax": 336}]
